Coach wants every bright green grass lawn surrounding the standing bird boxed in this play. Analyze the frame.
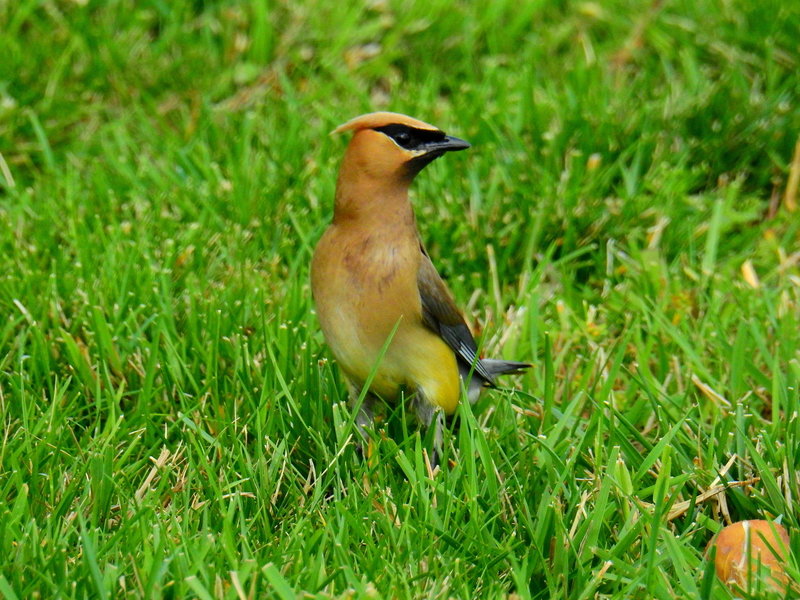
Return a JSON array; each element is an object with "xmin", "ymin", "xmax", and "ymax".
[{"xmin": 0, "ymin": 0, "xmax": 800, "ymax": 600}]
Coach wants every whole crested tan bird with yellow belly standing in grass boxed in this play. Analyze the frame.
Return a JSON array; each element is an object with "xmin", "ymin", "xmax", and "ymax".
[{"xmin": 311, "ymin": 112, "xmax": 531, "ymax": 466}]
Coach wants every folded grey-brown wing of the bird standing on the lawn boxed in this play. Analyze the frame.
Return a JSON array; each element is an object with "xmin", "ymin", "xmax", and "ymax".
[{"xmin": 417, "ymin": 244, "xmax": 494, "ymax": 385}]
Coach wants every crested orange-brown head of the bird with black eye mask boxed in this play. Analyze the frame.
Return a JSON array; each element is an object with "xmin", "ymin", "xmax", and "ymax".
[{"xmin": 334, "ymin": 112, "xmax": 470, "ymax": 181}]
